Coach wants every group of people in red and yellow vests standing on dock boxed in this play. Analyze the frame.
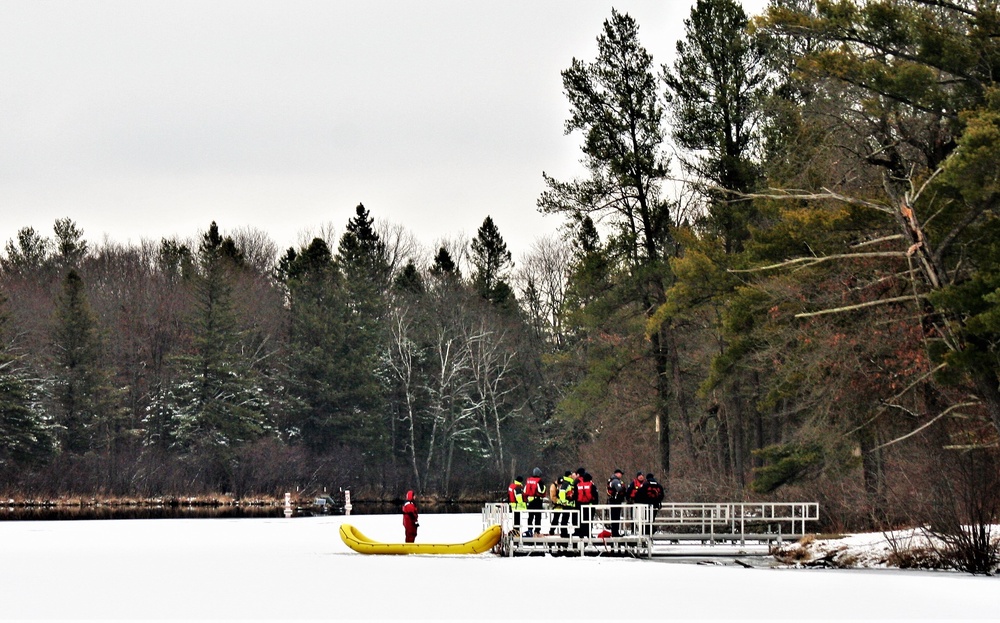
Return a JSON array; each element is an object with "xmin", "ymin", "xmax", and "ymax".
[{"xmin": 507, "ymin": 467, "xmax": 663, "ymax": 538}]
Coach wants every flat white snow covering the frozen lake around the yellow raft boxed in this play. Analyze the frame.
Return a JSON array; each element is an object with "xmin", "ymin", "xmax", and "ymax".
[{"xmin": 0, "ymin": 514, "xmax": 1000, "ymax": 621}]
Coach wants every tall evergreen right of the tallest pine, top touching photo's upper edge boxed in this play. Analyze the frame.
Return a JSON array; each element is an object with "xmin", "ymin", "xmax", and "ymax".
[{"xmin": 654, "ymin": 0, "xmax": 768, "ymax": 487}]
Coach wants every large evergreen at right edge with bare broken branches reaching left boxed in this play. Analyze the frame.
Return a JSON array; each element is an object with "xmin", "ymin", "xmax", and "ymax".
[{"xmin": 752, "ymin": 0, "xmax": 1000, "ymax": 444}]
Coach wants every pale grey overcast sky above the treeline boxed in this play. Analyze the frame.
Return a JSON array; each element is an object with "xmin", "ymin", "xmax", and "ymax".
[{"xmin": 0, "ymin": 0, "xmax": 764, "ymax": 255}]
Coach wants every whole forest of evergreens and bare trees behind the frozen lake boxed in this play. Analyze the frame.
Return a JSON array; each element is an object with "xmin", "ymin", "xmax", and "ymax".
[{"xmin": 0, "ymin": 0, "xmax": 1000, "ymax": 527}]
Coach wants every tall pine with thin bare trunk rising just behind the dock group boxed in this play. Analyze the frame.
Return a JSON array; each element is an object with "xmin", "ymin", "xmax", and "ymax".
[{"xmin": 538, "ymin": 10, "xmax": 674, "ymax": 473}]
